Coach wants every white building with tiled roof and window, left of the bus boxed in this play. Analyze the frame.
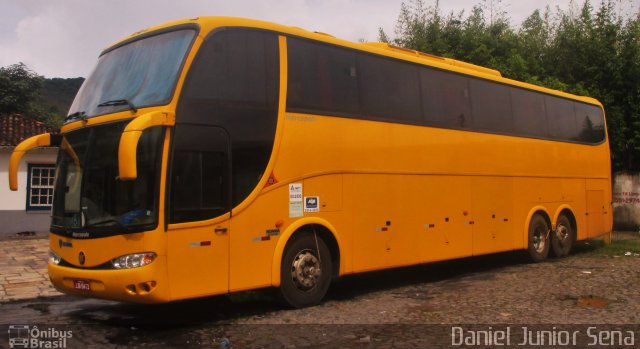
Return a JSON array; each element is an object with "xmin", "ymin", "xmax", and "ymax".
[{"xmin": 0, "ymin": 114, "xmax": 57, "ymax": 236}]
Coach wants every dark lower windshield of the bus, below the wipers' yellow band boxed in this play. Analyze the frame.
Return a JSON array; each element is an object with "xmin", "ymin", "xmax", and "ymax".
[{"xmin": 52, "ymin": 122, "xmax": 163, "ymax": 233}]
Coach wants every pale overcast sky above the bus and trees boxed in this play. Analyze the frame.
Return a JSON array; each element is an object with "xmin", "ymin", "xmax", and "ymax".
[{"xmin": 0, "ymin": 0, "xmax": 637, "ymax": 78}]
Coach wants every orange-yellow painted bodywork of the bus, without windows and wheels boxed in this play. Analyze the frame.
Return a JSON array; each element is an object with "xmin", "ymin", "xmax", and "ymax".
[{"xmin": 49, "ymin": 17, "xmax": 612, "ymax": 302}]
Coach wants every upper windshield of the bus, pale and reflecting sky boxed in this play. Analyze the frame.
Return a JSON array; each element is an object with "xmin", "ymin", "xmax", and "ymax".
[{"xmin": 67, "ymin": 29, "xmax": 195, "ymax": 120}]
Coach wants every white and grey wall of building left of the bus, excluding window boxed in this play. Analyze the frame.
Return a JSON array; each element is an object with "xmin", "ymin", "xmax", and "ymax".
[{"xmin": 0, "ymin": 148, "xmax": 57, "ymax": 236}]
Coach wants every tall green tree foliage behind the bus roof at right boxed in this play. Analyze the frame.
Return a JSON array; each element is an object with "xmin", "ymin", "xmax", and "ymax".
[{"xmin": 379, "ymin": 0, "xmax": 640, "ymax": 172}]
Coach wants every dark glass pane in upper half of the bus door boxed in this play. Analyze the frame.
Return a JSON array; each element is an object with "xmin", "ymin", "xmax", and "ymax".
[{"xmin": 170, "ymin": 124, "xmax": 229, "ymax": 223}]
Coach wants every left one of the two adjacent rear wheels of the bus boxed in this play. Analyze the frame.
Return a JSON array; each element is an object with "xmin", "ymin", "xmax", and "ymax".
[{"xmin": 525, "ymin": 207, "xmax": 552, "ymax": 262}]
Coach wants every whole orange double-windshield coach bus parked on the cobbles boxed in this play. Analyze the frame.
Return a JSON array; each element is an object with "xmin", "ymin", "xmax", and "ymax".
[{"xmin": 10, "ymin": 17, "xmax": 612, "ymax": 307}]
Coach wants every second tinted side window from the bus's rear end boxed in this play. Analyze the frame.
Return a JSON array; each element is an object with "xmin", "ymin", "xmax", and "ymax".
[{"xmin": 544, "ymin": 96, "xmax": 578, "ymax": 141}]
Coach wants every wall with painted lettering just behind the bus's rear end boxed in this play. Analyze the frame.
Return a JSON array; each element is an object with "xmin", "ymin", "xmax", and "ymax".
[{"xmin": 613, "ymin": 173, "xmax": 640, "ymax": 231}]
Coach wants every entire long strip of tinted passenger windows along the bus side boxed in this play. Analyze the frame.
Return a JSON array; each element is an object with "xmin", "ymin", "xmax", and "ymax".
[{"xmin": 287, "ymin": 38, "xmax": 605, "ymax": 143}]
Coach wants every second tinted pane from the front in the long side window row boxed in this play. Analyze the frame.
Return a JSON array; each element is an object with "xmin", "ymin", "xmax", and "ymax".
[{"xmin": 358, "ymin": 54, "xmax": 422, "ymax": 121}]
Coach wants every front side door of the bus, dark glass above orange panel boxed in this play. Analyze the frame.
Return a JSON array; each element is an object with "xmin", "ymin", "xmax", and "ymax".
[{"xmin": 167, "ymin": 124, "xmax": 231, "ymax": 298}]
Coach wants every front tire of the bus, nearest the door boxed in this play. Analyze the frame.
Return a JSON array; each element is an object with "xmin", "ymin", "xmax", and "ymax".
[{"xmin": 278, "ymin": 233, "xmax": 332, "ymax": 308}]
